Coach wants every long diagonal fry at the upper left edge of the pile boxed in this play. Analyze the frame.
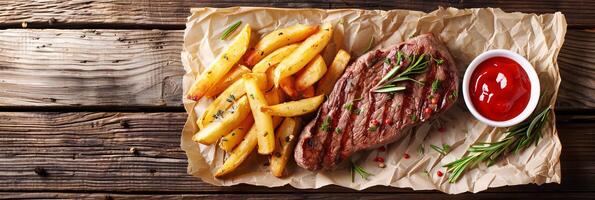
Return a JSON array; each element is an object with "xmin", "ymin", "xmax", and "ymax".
[{"xmin": 186, "ymin": 24, "xmax": 251, "ymax": 101}]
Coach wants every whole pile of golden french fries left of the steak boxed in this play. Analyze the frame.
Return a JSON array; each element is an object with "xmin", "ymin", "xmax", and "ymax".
[{"xmin": 187, "ymin": 24, "xmax": 350, "ymax": 177}]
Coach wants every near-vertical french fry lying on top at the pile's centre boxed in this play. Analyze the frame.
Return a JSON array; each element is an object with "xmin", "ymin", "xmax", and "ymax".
[{"xmin": 243, "ymin": 74, "xmax": 275, "ymax": 155}]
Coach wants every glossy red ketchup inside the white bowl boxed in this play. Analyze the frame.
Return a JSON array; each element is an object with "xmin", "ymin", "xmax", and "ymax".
[{"xmin": 469, "ymin": 57, "xmax": 531, "ymax": 121}]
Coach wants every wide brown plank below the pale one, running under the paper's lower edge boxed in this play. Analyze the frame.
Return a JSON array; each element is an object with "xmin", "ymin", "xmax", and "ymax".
[{"xmin": 0, "ymin": 112, "xmax": 595, "ymax": 193}]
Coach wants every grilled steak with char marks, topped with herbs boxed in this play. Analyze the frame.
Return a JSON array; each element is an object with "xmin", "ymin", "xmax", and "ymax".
[{"xmin": 294, "ymin": 34, "xmax": 458, "ymax": 170}]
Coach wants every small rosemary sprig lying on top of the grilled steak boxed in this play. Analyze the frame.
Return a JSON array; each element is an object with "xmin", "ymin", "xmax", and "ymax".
[{"xmin": 374, "ymin": 51, "xmax": 428, "ymax": 93}]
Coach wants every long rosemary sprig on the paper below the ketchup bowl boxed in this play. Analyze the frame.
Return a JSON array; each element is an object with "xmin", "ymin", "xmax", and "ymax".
[{"xmin": 444, "ymin": 106, "xmax": 551, "ymax": 183}]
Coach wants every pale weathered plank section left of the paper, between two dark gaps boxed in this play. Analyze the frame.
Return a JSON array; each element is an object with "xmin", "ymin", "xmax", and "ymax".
[{"xmin": 0, "ymin": 28, "xmax": 184, "ymax": 106}]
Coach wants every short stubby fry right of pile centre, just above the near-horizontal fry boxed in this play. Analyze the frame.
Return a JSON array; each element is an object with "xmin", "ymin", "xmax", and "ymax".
[{"xmin": 295, "ymin": 54, "xmax": 326, "ymax": 91}]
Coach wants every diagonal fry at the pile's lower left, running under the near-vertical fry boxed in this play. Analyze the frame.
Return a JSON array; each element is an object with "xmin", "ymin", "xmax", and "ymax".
[{"xmin": 215, "ymin": 117, "xmax": 281, "ymax": 177}]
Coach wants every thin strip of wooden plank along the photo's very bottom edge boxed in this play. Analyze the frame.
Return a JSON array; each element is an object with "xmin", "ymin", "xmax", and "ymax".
[{"xmin": 0, "ymin": 192, "xmax": 595, "ymax": 200}]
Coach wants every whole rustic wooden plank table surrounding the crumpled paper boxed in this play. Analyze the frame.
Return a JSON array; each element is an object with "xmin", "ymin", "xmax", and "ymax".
[{"xmin": 0, "ymin": 0, "xmax": 595, "ymax": 199}]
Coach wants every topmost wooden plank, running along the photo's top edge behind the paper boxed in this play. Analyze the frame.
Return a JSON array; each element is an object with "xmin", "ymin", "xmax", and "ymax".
[{"xmin": 0, "ymin": 0, "xmax": 595, "ymax": 28}]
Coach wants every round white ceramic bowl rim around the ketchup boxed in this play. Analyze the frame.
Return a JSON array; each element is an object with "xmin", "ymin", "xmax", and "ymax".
[{"xmin": 462, "ymin": 49, "xmax": 541, "ymax": 127}]
